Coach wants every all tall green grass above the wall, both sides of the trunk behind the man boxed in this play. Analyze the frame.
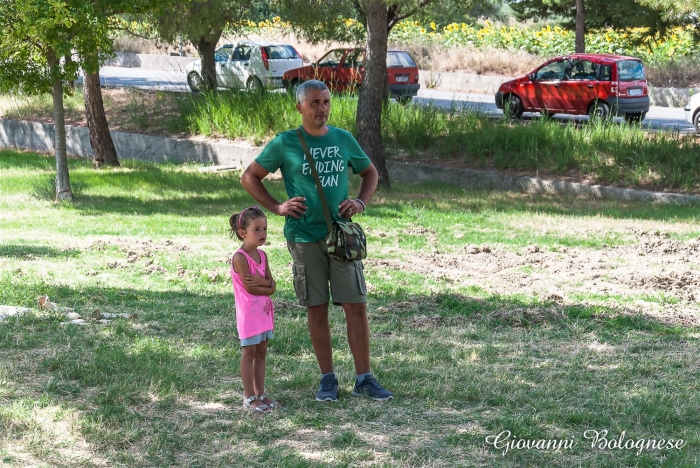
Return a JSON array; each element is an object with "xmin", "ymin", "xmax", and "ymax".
[{"xmin": 175, "ymin": 92, "xmax": 700, "ymax": 191}]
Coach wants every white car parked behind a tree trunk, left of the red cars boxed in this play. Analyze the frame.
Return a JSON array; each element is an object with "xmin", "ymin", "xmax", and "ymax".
[{"xmin": 185, "ymin": 41, "xmax": 303, "ymax": 91}]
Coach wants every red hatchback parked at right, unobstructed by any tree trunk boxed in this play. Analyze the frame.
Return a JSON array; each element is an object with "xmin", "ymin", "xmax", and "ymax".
[{"xmin": 496, "ymin": 54, "xmax": 649, "ymax": 122}]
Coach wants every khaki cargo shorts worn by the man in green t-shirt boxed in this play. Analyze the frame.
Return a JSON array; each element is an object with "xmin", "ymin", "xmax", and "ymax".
[{"xmin": 287, "ymin": 240, "xmax": 367, "ymax": 307}]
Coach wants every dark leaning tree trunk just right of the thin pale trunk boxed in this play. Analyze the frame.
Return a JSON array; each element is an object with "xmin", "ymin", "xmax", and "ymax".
[{"xmin": 83, "ymin": 65, "xmax": 119, "ymax": 167}]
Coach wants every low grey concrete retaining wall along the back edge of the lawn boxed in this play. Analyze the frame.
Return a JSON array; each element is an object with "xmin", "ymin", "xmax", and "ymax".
[{"xmin": 0, "ymin": 119, "xmax": 700, "ymax": 205}]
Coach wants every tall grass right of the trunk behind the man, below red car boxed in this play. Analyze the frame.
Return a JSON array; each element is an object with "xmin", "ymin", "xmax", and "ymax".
[{"xmin": 383, "ymin": 105, "xmax": 700, "ymax": 191}]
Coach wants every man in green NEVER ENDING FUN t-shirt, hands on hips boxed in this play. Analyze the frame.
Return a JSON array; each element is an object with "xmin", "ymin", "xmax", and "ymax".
[{"xmin": 241, "ymin": 80, "xmax": 394, "ymax": 401}]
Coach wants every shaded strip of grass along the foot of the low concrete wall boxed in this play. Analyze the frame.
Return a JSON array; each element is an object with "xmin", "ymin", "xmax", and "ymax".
[{"xmin": 5, "ymin": 151, "xmax": 700, "ymax": 221}]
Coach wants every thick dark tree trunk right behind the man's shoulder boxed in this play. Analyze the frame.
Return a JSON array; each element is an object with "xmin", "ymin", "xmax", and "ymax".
[{"xmin": 356, "ymin": 0, "xmax": 391, "ymax": 188}]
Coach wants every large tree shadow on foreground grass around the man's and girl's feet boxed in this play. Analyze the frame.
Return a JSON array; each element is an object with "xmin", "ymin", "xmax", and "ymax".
[{"xmin": 0, "ymin": 274, "xmax": 695, "ymax": 466}]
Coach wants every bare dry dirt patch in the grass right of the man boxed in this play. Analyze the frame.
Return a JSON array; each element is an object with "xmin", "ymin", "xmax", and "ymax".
[{"xmin": 366, "ymin": 227, "xmax": 700, "ymax": 326}]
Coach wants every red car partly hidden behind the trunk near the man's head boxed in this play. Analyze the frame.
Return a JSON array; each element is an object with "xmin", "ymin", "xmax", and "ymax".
[{"xmin": 282, "ymin": 49, "xmax": 420, "ymax": 103}]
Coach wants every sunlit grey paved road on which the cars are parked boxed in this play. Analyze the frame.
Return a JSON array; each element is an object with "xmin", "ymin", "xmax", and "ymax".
[{"xmin": 100, "ymin": 67, "xmax": 694, "ymax": 133}]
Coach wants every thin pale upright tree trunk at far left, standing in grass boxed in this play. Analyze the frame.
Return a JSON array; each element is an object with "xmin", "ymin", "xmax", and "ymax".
[{"xmin": 49, "ymin": 53, "xmax": 73, "ymax": 201}]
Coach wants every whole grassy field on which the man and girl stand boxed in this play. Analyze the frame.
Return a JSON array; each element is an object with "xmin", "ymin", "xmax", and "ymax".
[{"xmin": 0, "ymin": 152, "xmax": 700, "ymax": 468}]
